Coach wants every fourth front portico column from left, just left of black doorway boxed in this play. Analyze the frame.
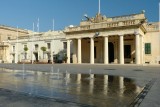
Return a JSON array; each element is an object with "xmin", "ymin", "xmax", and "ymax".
[{"xmin": 104, "ymin": 36, "xmax": 108, "ymax": 64}]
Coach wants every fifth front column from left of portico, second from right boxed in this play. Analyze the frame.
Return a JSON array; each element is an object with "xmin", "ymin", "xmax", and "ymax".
[{"xmin": 119, "ymin": 35, "xmax": 124, "ymax": 64}]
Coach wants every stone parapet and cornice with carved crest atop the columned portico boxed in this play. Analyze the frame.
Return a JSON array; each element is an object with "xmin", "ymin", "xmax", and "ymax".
[{"xmin": 64, "ymin": 12, "xmax": 147, "ymax": 34}]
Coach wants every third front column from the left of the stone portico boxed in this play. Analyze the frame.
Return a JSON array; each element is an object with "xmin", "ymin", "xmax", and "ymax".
[{"xmin": 90, "ymin": 37, "xmax": 94, "ymax": 64}]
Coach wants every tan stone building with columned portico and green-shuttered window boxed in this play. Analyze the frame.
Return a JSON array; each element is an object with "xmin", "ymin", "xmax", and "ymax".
[{"xmin": 64, "ymin": 11, "xmax": 160, "ymax": 64}]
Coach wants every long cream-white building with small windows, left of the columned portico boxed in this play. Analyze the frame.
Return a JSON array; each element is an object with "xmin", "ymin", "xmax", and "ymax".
[{"xmin": 3, "ymin": 31, "xmax": 66, "ymax": 63}]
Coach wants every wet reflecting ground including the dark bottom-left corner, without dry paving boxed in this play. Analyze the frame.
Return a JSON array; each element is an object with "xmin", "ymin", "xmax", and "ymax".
[{"xmin": 0, "ymin": 67, "xmax": 143, "ymax": 107}]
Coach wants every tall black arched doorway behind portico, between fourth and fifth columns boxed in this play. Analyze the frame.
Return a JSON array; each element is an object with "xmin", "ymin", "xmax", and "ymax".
[{"xmin": 108, "ymin": 42, "xmax": 114, "ymax": 63}]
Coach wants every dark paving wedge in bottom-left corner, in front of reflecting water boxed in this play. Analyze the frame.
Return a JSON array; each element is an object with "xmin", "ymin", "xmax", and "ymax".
[{"xmin": 0, "ymin": 89, "xmax": 93, "ymax": 107}]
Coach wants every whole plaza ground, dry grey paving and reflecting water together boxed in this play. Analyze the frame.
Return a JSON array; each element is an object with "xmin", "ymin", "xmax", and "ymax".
[{"xmin": 0, "ymin": 64, "xmax": 160, "ymax": 107}]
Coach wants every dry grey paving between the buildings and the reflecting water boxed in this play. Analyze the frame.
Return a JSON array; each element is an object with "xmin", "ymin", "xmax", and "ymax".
[{"xmin": 0, "ymin": 64, "xmax": 160, "ymax": 107}]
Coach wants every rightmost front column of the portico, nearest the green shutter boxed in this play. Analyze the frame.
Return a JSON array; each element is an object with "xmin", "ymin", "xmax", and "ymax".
[{"xmin": 135, "ymin": 33, "xmax": 140, "ymax": 64}]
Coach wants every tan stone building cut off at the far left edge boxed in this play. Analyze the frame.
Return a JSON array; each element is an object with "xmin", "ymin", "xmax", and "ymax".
[{"xmin": 0, "ymin": 25, "xmax": 30, "ymax": 63}]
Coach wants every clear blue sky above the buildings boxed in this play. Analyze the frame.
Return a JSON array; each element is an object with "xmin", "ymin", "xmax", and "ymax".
[{"xmin": 0, "ymin": 0, "xmax": 160, "ymax": 31}]
